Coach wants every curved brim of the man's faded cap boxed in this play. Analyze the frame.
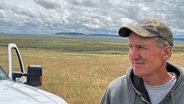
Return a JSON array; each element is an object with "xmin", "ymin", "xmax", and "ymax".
[{"xmin": 119, "ymin": 26, "xmax": 156, "ymax": 37}]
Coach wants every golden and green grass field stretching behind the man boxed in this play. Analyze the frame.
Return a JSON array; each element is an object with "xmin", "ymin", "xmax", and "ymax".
[{"xmin": 0, "ymin": 35, "xmax": 184, "ymax": 104}]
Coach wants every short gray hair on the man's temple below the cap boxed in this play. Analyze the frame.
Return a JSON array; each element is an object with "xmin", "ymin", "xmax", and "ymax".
[{"xmin": 155, "ymin": 37, "xmax": 170, "ymax": 48}]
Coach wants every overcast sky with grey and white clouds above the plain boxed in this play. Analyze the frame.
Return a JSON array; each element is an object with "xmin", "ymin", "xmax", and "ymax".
[{"xmin": 0, "ymin": 0, "xmax": 184, "ymax": 35}]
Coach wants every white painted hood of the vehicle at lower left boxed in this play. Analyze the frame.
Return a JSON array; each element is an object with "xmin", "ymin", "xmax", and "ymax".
[{"xmin": 0, "ymin": 80, "xmax": 67, "ymax": 104}]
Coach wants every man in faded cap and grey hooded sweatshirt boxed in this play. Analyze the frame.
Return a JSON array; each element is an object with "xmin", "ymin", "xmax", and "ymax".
[{"xmin": 101, "ymin": 19, "xmax": 184, "ymax": 104}]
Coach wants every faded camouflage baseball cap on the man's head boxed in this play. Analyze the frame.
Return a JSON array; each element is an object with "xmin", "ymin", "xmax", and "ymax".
[{"xmin": 119, "ymin": 18, "xmax": 173, "ymax": 47}]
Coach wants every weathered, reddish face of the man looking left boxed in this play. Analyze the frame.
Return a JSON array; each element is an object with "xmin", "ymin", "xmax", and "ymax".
[{"xmin": 128, "ymin": 32, "xmax": 166, "ymax": 77}]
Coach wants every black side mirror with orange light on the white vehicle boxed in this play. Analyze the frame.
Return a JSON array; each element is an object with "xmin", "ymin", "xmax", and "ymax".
[{"xmin": 26, "ymin": 65, "xmax": 42, "ymax": 86}]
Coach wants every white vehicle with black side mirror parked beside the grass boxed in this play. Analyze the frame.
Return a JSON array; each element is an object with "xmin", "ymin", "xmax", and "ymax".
[{"xmin": 0, "ymin": 43, "xmax": 67, "ymax": 104}]
